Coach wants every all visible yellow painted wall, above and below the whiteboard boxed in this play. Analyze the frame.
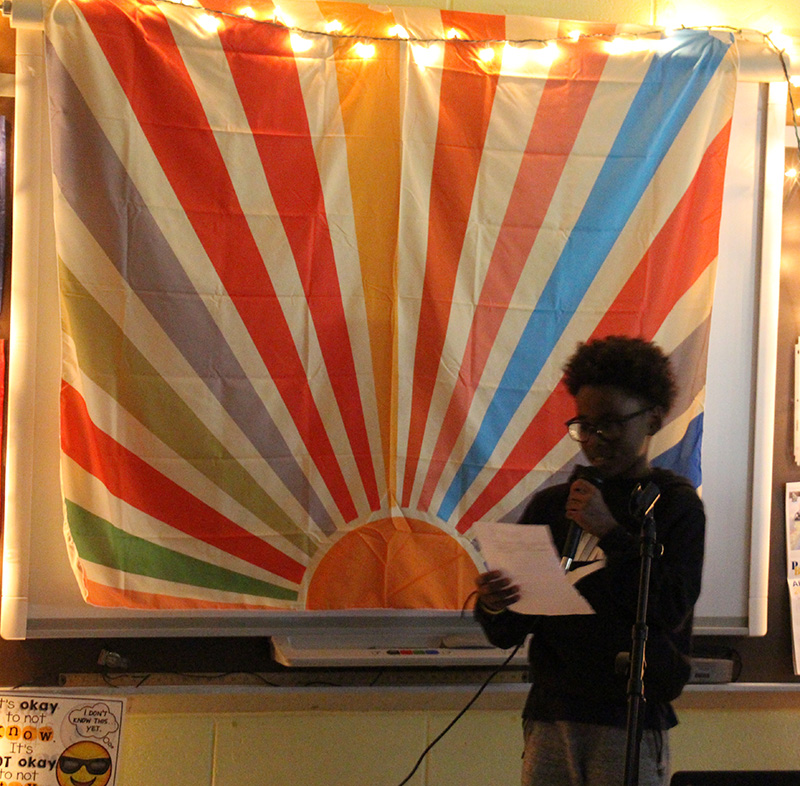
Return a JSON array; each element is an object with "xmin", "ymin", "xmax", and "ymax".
[{"xmin": 0, "ymin": 0, "xmax": 800, "ymax": 786}]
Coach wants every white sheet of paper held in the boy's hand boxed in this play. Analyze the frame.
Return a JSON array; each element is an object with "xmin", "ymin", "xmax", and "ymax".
[{"xmin": 472, "ymin": 521, "xmax": 602, "ymax": 614}]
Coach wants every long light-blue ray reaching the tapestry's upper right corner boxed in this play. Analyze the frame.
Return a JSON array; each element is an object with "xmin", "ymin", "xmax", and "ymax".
[{"xmin": 437, "ymin": 30, "xmax": 730, "ymax": 520}]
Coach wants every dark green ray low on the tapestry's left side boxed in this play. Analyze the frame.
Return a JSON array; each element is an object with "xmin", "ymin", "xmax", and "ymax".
[{"xmin": 65, "ymin": 500, "xmax": 297, "ymax": 600}]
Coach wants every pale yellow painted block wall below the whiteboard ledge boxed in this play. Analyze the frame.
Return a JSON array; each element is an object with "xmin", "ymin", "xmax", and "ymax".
[{"xmin": 109, "ymin": 689, "xmax": 800, "ymax": 786}]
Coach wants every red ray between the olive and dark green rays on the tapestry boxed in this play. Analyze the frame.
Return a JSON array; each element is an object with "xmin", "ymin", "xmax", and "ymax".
[{"xmin": 61, "ymin": 382, "xmax": 305, "ymax": 584}]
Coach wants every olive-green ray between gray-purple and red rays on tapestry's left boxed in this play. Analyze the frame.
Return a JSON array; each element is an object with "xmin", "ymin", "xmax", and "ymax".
[{"xmin": 60, "ymin": 260, "xmax": 316, "ymax": 554}]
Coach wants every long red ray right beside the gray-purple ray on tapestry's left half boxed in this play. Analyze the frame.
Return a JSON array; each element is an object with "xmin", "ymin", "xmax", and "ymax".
[{"xmin": 80, "ymin": 0, "xmax": 357, "ymax": 521}]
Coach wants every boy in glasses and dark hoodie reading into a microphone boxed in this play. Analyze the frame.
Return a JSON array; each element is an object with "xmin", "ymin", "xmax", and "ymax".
[{"xmin": 475, "ymin": 337, "xmax": 705, "ymax": 786}]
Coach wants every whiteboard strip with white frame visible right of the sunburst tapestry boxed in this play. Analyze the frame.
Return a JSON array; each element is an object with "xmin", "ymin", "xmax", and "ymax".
[{"xmin": 695, "ymin": 83, "xmax": 786, "ymax": 635}]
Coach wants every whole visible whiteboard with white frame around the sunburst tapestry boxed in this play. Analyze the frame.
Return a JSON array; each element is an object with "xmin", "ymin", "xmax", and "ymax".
[{"xmin": 0, "ymin": 30, "xmax": 786, "ymax": 646}]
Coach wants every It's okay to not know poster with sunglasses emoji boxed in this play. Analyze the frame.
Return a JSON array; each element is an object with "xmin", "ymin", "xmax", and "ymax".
[{"xmin": 0, "ymin": 692, "xmax": 125, "ymax": 786}]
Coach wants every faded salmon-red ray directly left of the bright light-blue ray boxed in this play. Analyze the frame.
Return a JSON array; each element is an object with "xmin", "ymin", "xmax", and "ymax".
[{"xmin": 418, "ymin": 26, "xmax": 614, "ymax": 510}]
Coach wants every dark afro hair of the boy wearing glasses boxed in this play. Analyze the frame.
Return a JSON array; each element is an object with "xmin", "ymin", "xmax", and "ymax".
[{"xmin": 564, "ymin": 336, "xmax": 677, "ymax": 413}]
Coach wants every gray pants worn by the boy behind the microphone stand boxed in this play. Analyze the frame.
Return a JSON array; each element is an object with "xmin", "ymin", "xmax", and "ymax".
[{"xmin": 522, "ymin": 720, "xmax": 670, "ymax": 786}]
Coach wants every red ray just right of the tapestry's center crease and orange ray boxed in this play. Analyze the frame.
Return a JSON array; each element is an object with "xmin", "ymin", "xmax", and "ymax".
[{"xmin": 402, "ymin": 11, "xmax": 505, "ymax": 507}]
